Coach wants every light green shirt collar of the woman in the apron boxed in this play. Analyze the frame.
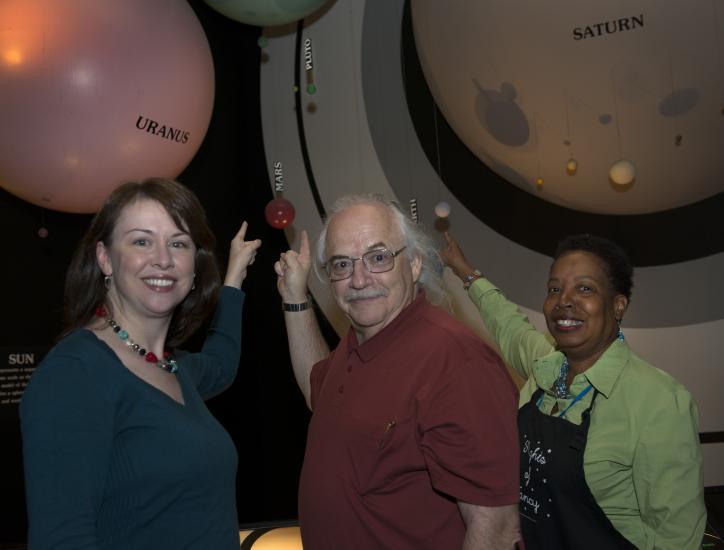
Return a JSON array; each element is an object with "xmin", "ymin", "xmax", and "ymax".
[{"xmin": 533, "ymin": 340, "xmax": 631, "ymax": 398}]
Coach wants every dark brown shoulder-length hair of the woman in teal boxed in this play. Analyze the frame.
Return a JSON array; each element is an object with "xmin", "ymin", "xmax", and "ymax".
[{"xmin": 62, "ymin": 178, "xmax": 221, "ymax": 347}]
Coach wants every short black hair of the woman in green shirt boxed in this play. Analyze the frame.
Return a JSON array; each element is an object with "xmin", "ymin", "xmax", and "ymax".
[{"xmin": 553, "ymin": 233, "xmax": 633, "ymax": 300}]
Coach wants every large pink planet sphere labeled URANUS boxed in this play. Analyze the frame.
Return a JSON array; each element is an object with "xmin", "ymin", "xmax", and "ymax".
[{"xmin": 0, "ymin": 0, "xmax": 214, "ymax": 212}]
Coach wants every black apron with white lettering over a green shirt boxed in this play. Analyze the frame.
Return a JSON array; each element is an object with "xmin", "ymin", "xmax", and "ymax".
[{"xmin": 518, "ymin": 388, "xmax": 636, "ymax": 550}]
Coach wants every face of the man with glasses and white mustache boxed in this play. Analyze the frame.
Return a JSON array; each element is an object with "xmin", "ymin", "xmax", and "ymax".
[{"xmin": 326, "ymin": 204, "xmax": 421, "ymax": 343}]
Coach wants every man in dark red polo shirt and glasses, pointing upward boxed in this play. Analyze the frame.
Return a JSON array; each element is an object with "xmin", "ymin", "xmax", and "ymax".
[{"xmin": 274, "ymin": 196, "xmax": 520, "ymax": 550}]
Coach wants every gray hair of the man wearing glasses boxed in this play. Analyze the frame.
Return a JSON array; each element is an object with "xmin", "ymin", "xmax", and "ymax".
[{"xmin": 314, "ymin": 193, "xmax": 450, "ymax": 310}]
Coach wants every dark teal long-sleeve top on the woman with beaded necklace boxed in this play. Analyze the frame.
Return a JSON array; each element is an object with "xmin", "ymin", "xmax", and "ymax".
[{"xmin": 20, "ymin": 287, "xmax": 244, "ymax": 550}]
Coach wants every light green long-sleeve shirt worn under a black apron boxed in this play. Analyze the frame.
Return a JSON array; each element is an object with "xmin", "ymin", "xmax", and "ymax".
[{"xmin": 469, "ymin": 279, "xmax": 706, "ymax": 550}]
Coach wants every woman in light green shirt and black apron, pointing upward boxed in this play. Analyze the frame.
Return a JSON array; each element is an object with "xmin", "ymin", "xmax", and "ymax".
[{"xmin": 442, "ymin": 235, "xmax": 706, "ymax": 550}]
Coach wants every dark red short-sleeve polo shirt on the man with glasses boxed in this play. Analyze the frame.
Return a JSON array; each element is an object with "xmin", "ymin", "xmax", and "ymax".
[{"xmin": 299, "ymin": 293, "xmax": 519, "ymax": 550}]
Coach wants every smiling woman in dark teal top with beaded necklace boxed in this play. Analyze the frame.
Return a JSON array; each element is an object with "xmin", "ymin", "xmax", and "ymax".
[{"xmin": 20, "ymin": 179, "xmax": 261, "ymax": 550}]
